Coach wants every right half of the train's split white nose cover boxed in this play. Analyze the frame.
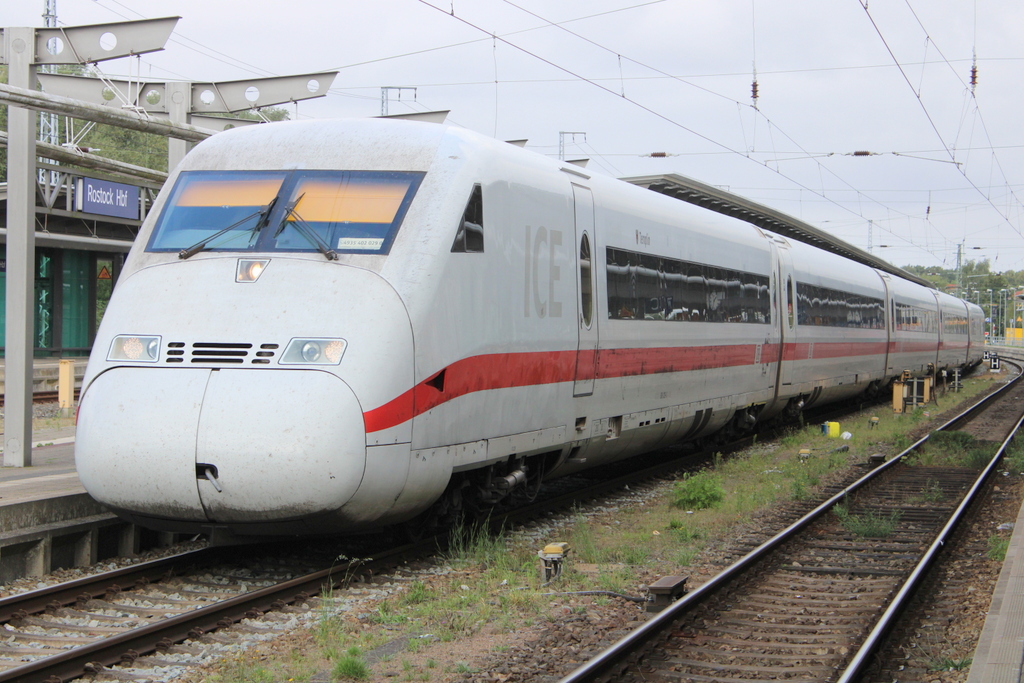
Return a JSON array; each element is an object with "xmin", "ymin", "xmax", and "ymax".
[{"xmin": 194, "ymin": 370, "xmax": 366, "ymax": 523}]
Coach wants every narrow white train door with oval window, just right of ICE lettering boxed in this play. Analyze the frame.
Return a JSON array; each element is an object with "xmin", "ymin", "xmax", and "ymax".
[{"xmin": 572, "ymin": 184, "xmax": 598, "ymax": 396}]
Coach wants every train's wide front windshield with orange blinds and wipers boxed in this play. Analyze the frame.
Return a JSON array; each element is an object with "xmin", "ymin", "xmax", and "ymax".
[{"xmin": 146, "ymin": 171, "xmax": 423, "ymax": 257}]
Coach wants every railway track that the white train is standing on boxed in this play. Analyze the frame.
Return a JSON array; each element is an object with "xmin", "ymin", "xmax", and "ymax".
[{"xmin": 0, "ymin": 360, "xmax": 1007, "ymax": 683}]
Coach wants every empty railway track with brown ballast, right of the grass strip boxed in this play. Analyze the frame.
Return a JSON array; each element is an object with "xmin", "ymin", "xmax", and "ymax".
[{"xmin": 561, "ymin": 356, "xmax": 1024, "ymax": 683}]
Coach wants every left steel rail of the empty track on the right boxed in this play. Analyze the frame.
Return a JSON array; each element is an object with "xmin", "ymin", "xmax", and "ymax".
[{"xmin": 558, "ymin": 362, "xmax": 1024, "ymax": 683}]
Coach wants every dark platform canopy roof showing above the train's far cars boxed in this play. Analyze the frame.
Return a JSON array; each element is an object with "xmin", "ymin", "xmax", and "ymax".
[{"xmin": 622, "ymin": 173, "xmax": 934, "ymax": 289}]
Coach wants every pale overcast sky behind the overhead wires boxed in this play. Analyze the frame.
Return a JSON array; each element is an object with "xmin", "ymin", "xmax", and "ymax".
[{"xmin": 8, "ymin": 0, "xmax": 1024, "ymax": 278}]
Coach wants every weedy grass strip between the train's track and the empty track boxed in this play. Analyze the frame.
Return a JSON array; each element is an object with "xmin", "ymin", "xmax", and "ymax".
[{"xmin": 192, "ymin": 374, "xmax": 1007, "ymax": 683}]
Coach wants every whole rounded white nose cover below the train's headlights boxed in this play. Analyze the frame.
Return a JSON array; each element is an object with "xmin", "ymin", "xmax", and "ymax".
[{"xmin": 76, "ymin": 368, "xmax": 366, "ymax": 526}]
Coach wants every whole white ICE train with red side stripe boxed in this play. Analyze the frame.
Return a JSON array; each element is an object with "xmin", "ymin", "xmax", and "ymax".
[{"xmin": 76, "ymin": 120, "xmax": 982, "ymax": 540}]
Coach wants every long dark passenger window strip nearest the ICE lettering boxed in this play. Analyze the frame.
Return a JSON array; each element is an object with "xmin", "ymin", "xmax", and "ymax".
[{"xmin": 605, "ymin": 247, "xmax": 771, "ymax": 324}]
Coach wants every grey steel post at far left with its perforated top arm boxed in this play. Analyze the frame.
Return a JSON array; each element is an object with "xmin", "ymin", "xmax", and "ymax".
[{"xmin": 0, "ymin": 17, "xmax": 178, "ymax": 467}]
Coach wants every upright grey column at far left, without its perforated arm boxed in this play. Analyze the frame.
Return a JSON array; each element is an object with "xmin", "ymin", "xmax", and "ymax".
[{"xmin": 3, "ymin": 28, "xmax": 36, "ymax": 467}]
